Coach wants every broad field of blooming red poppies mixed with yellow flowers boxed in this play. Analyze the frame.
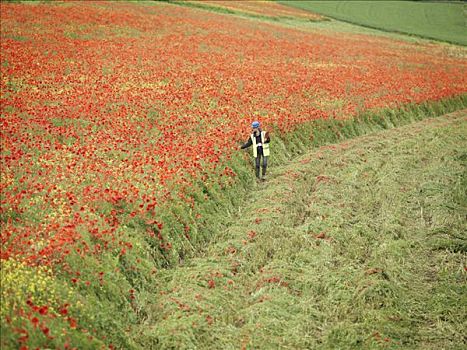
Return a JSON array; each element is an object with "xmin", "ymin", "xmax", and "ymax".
[{"xmin": 0, "ymin": 2, "xmax": 467, "ymax": 345}]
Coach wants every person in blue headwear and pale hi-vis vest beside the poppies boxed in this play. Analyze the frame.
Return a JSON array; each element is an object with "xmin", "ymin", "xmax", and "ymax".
[{"xmin": 240, "ymin": 121, "xmax": 271, "ymax": 181}]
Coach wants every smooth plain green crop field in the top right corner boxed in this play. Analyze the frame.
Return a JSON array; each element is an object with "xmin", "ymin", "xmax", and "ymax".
[{"xmin": 281, "ymin": 1, "xmax": 467, "ymax": 45}]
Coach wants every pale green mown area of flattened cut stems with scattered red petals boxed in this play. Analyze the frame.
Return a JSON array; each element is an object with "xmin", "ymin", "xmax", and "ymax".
[{"xmin": 130, "ymin": 110, "xmax": 467, "ymax": 349}]
